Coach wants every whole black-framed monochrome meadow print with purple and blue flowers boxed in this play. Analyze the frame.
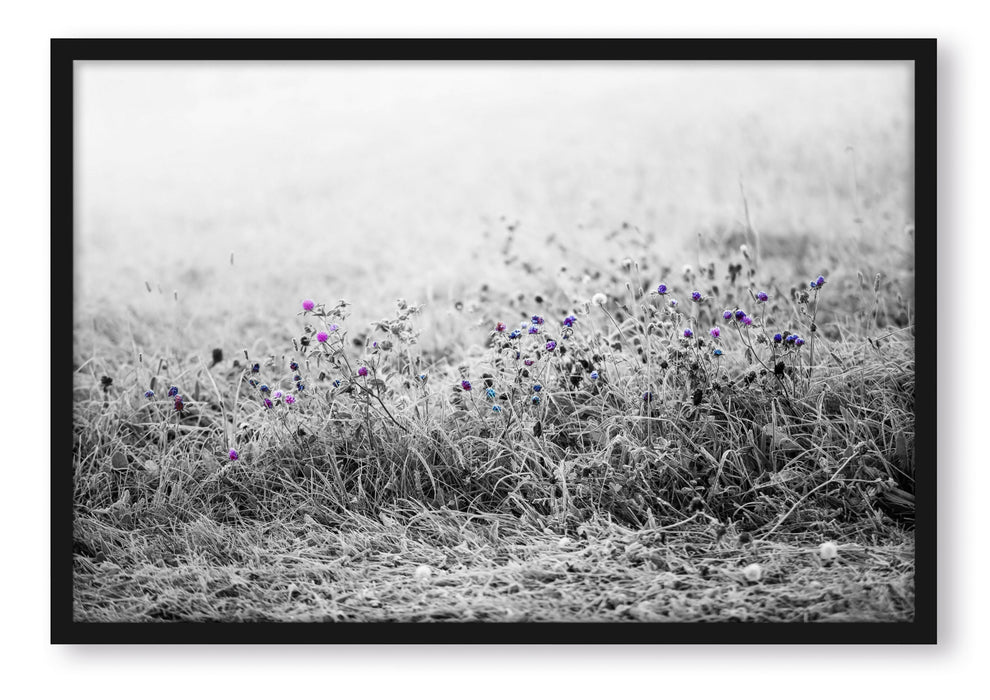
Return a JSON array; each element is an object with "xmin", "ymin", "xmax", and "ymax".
[{"xmin": 52, "ymin": 39, "xmax": 936, "ymax": 643}]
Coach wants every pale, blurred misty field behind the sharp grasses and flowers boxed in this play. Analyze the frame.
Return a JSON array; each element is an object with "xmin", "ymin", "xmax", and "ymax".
[{"xmin": 74, "ymin": 62, "xmax": 913, "ymax": 356}]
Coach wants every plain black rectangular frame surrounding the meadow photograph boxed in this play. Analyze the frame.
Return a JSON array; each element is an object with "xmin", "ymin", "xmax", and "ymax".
[{"xmin": 51, "ymin": 39, "xmax": 937, "ymax": 644}]
